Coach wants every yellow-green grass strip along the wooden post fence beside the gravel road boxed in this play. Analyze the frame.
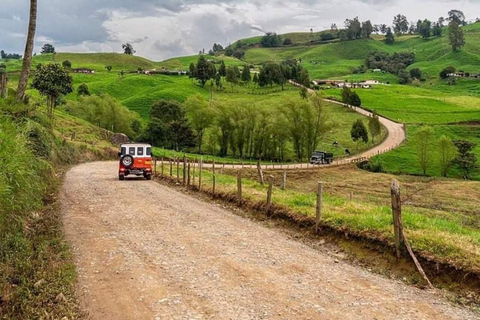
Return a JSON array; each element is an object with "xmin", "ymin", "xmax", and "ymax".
[{"xmin": 157, "ymin": 165, "xmax": 480, "ymax": 272}]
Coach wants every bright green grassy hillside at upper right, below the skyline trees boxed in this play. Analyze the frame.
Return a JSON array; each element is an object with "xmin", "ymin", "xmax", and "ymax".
[{"xmin": 242, "ymin": 23, "xmax": 480, "ymax": 79}]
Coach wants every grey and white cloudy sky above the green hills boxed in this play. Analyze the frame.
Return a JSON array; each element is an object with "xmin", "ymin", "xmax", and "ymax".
[{"xmin": 0, "ymin": 0, "xmax": 480, "ymax": 60}]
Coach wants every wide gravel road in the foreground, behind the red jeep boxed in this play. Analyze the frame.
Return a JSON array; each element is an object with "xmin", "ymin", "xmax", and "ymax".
[{"xmin": 62, "ymin": 162, "xmax": 478, "ymax": 320}]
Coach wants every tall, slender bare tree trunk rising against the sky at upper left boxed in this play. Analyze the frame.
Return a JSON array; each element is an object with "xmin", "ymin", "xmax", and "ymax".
[{"xmin": 16, "ymin": 0, "xmax": 37, "ymax": 101}]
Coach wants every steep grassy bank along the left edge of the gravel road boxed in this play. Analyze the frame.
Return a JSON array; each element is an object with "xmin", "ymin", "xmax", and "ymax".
[{"xmin": 0, "ymin": 99, "xmax": 114, "ymax": 319}]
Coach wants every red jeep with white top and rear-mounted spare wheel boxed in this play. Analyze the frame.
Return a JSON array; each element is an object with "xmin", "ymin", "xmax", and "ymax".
[{"xmin": 118, "ymin": 143, "xmax": 152, "ymax": 180}]
